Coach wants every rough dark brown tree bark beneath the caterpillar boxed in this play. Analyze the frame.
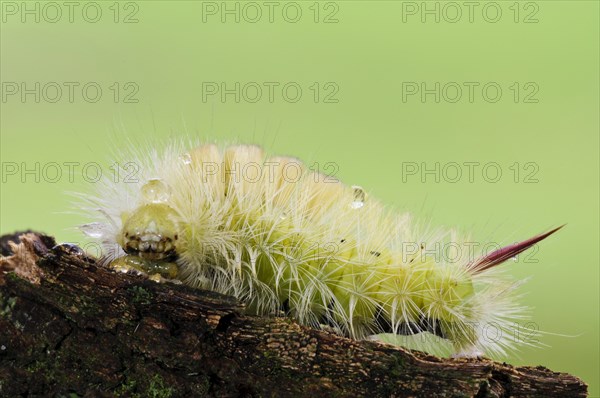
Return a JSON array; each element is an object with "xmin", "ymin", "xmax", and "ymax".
[{"xmin": 0, "ymin": 233, "xmax": 587, "ymax": 397}]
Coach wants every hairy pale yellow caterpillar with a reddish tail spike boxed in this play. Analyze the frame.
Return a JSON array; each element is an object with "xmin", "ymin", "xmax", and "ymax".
[{"xmin": 77, "ymin": 143, "xmax": 558, "ymax": 356}]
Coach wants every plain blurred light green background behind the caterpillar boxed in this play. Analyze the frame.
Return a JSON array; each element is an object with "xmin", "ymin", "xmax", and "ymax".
[{"xmin": 0, "ymin": 1, "xmax": 600, "ymax": 396}]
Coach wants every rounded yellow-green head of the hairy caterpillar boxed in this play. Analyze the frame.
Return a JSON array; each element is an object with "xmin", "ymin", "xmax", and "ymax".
[{"xmin": 119, "ymin": 203, "xmax": 179, "ymax": 261}]
